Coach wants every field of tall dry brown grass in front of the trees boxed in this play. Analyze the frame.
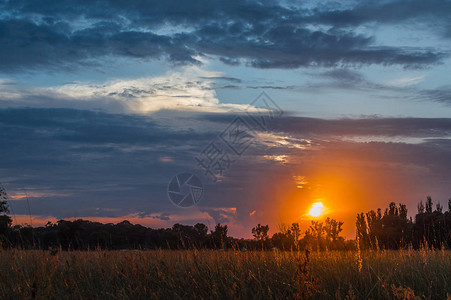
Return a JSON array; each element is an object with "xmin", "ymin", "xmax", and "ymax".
[{"xmin": 0, "ymin": 250, "xmax": 451, "ymax": 299}]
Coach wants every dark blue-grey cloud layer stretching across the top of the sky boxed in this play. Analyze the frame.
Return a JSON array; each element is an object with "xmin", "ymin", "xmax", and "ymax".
[{"xmin": 0, "ymin": 0, "xmax": 449, "ymax": 72}]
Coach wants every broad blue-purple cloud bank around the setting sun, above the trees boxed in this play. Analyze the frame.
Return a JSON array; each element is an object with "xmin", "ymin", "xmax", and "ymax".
[{"xmin": 0, "ymin": 108, "xmax": 451, "ymax": 237}]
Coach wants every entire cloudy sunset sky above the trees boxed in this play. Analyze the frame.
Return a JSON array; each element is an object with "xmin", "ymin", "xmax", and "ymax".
[{"xmin": 0, "ymin": 0, "xmax": 451, "ymax": 238}]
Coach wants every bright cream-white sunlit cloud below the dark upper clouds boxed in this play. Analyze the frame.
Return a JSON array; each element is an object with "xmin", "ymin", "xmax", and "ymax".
[{"xmin": 0, "ymin": 67, "xmax": 252, "ymax": 114}]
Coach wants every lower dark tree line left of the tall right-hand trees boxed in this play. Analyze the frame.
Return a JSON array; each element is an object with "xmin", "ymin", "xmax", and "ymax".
[{"xmin": 0, "ymin": 200, "xmax": 352, "ymax": 250}]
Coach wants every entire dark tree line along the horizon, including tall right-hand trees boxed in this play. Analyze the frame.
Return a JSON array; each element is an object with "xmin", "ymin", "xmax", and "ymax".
[{"xmin": 0, "ymin": 186, "xmax": 451, "ymax": 250}]
